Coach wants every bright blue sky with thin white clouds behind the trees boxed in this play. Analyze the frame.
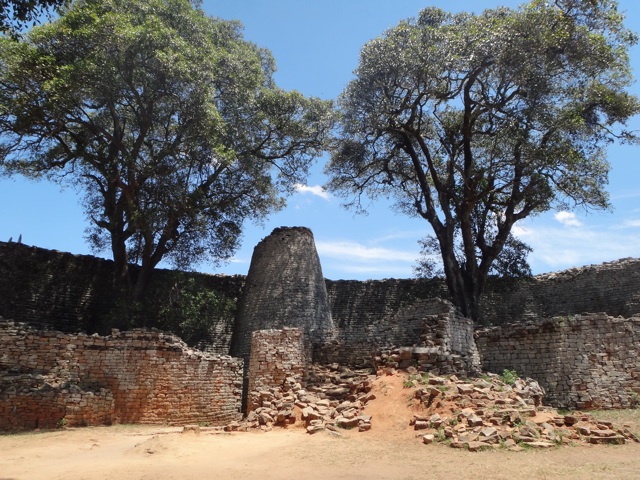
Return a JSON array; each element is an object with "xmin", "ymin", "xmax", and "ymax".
[{"xmin": 0, "ymin": 0, "xmax": 640, "ymax": 280}]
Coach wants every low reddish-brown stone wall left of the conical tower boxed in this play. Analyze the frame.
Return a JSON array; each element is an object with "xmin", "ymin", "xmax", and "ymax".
[{"xmin": 0, "ymin": 318, "xmax": 243, "ymax": 430}]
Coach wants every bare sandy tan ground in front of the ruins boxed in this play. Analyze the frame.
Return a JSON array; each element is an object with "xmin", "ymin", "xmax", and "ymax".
[{"xmin": 0, "ymin": 376, "xmax": 640, "ymax": 480}]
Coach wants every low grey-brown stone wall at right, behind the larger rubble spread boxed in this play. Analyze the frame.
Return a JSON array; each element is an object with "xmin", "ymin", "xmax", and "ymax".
[{"xmin": 476, "ymin": 313, "xmax": 640, "ymax": 409}]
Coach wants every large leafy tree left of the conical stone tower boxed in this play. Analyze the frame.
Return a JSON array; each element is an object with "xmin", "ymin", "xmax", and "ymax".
[{"xmin": 0, "ymin": 0, "xmax": 333, "ymax": 300}]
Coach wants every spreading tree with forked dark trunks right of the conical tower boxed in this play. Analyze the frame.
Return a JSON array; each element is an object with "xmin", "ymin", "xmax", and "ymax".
[{"xmin": 327, "ymin": 0, "xmax": 640, "ymax": 319}]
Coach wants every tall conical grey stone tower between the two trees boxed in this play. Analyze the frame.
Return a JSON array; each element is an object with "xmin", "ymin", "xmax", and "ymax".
[{"xmin": 231, "ymin": 227, "xmax": 333, "ymax": 359}]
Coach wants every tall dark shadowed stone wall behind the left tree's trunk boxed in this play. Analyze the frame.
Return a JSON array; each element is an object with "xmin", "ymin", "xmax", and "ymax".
[{"xmin": 0, "ymin": 242, "xmax": 244, "ymax": 355}]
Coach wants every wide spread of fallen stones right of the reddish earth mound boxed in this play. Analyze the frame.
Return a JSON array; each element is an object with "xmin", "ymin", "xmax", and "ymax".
[{"xmin": 405, "ymin": 370, "xmax": 640, "ymax": 451}]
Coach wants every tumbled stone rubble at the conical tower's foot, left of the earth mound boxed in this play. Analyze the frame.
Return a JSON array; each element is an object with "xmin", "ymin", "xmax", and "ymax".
[{"xmin": 225, "ymin": 364, "xmax": 376, "ymax": 433}]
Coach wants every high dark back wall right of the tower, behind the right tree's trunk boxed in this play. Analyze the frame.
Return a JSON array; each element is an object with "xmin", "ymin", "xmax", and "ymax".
[{"xmin": 327, "ymin": 258, "xmax": 640, "ymax": 327}]
